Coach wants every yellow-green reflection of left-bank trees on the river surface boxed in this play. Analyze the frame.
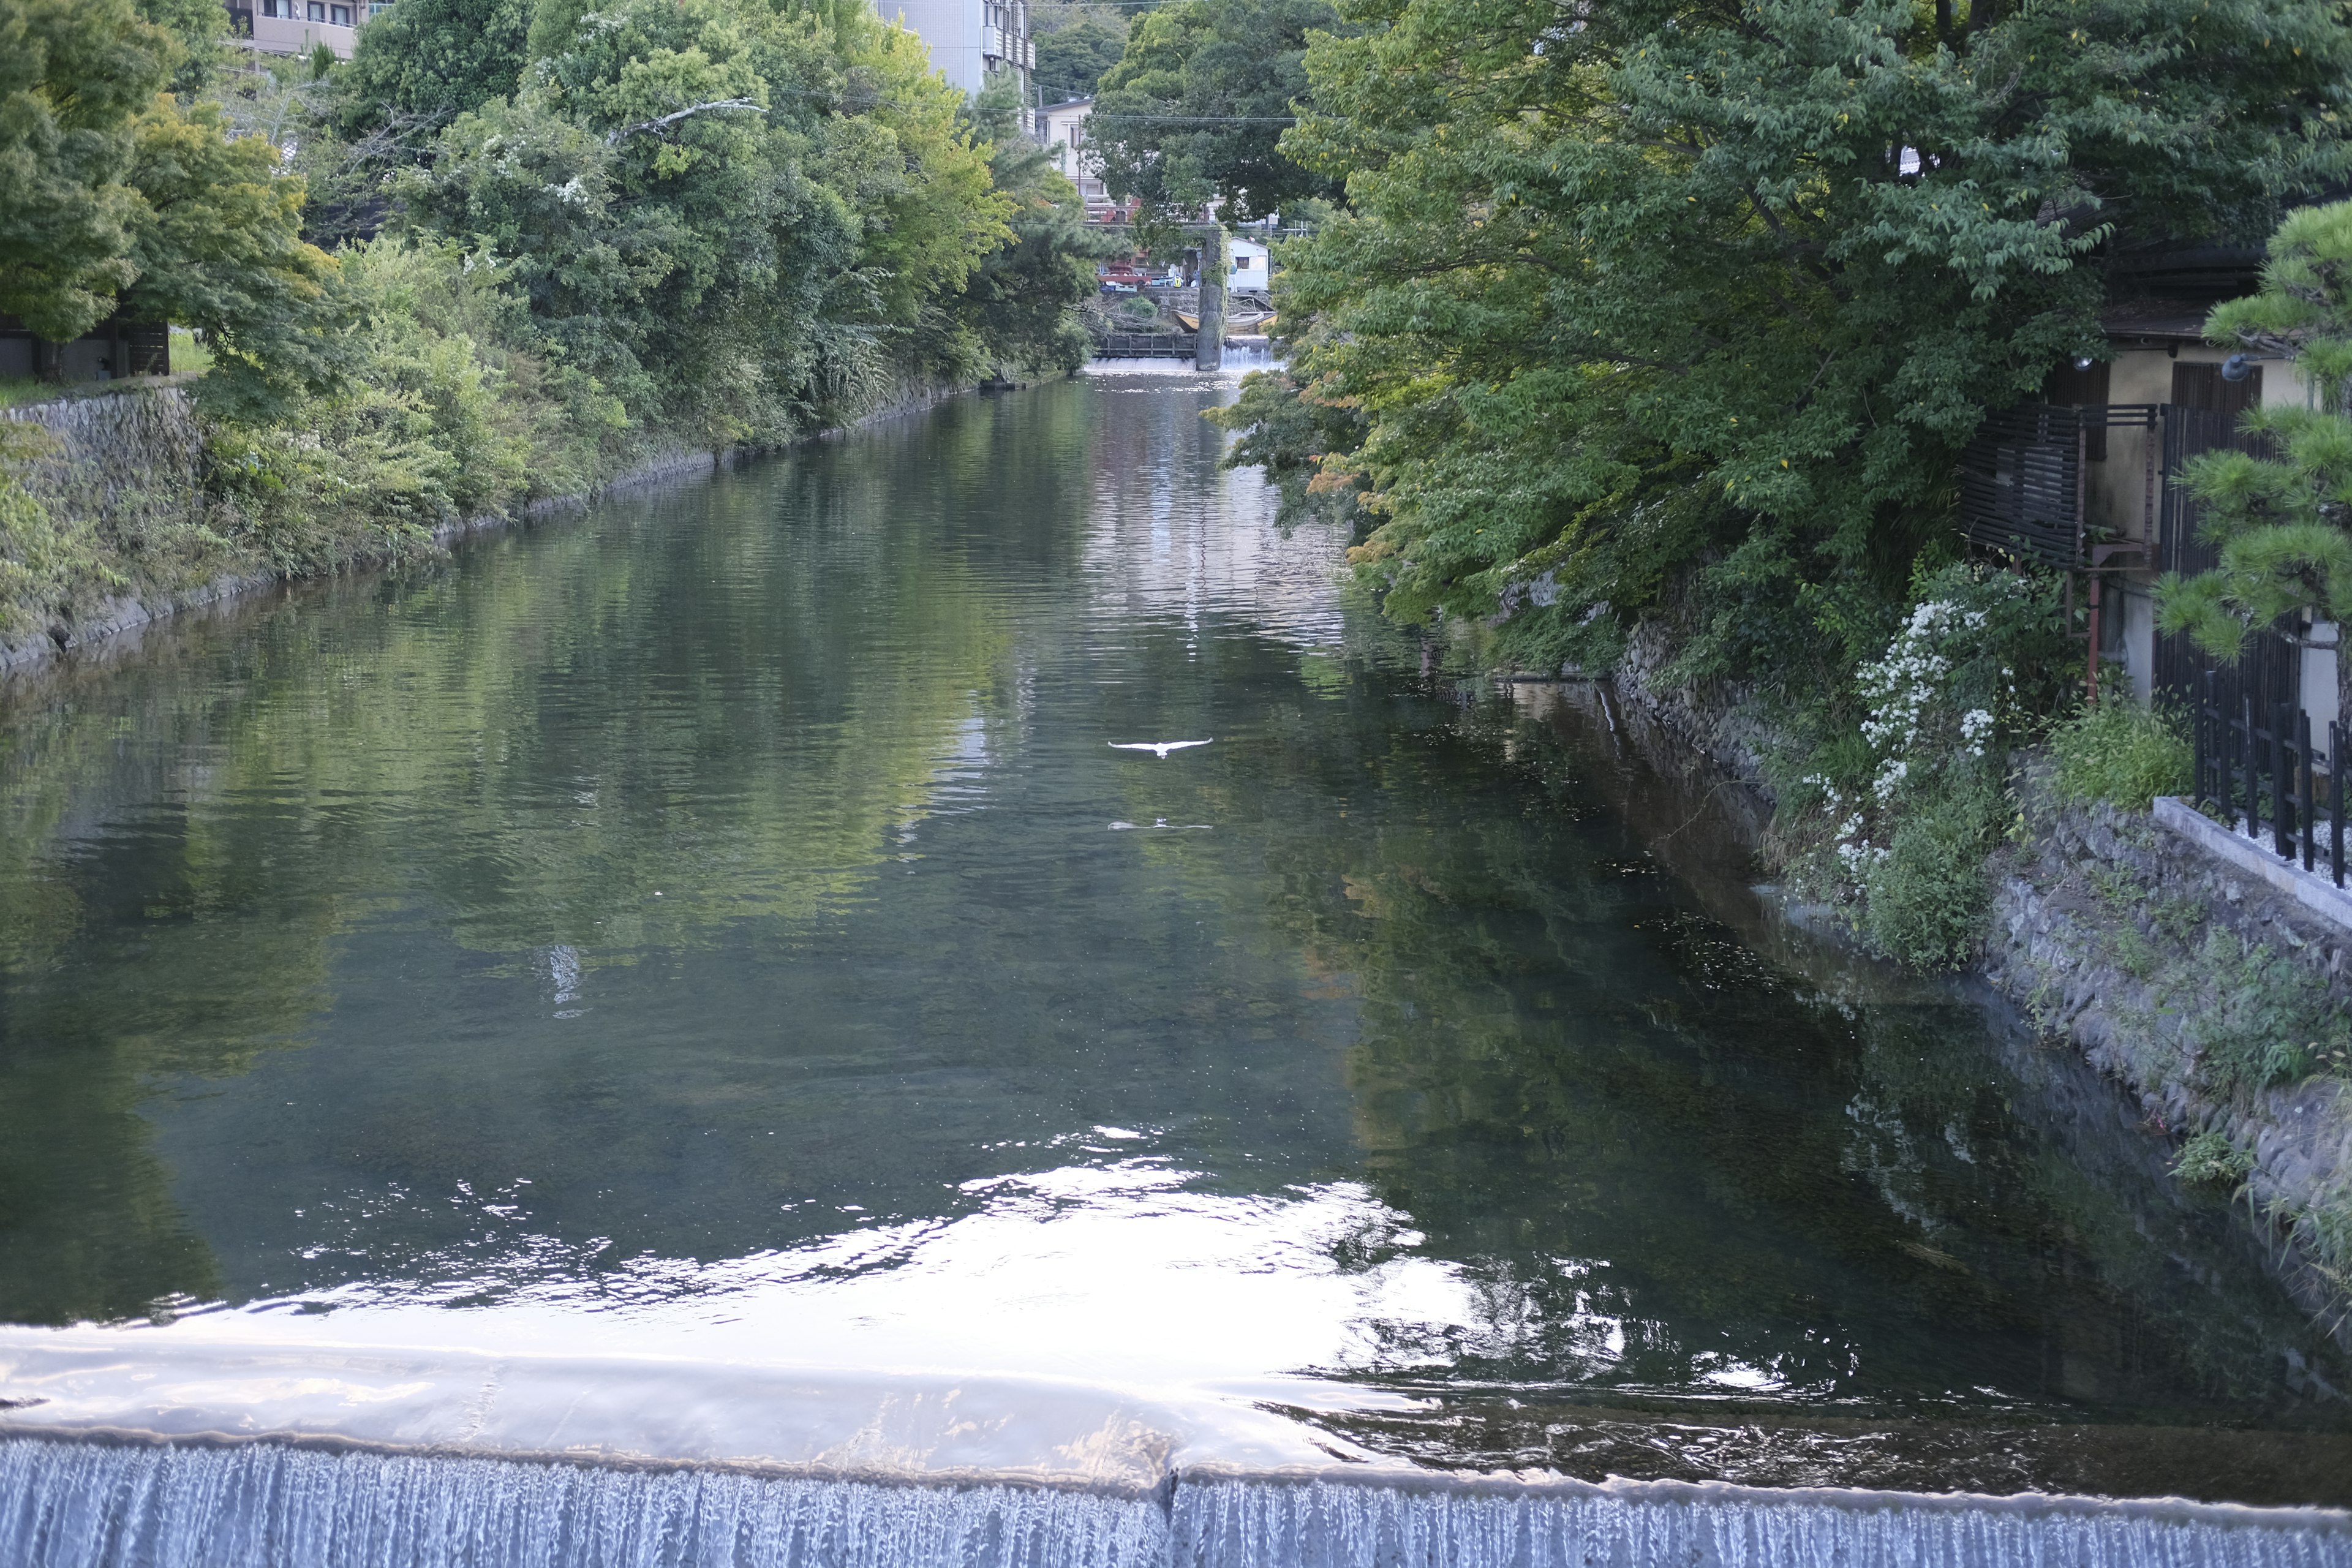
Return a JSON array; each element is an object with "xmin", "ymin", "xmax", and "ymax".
[{"xmin": 0, "ymin": 399, "xmax": 1089, "ymax": 1321}]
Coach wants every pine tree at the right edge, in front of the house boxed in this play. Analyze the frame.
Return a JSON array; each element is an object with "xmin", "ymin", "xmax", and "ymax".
[{"xmin": 2157, "ymin": 202, "xmax": 2352, "ymax": 712}]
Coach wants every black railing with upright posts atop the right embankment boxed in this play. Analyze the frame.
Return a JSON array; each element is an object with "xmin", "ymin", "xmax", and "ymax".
[{"xmin": 2195, "ymin": 670, "xmax": 2345, "ymax": 886}]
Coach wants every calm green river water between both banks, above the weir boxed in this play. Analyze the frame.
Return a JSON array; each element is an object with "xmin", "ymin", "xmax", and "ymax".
[{"xmin": 0, "ymin": 379, "xmax": 2352, "ymax": 1502}]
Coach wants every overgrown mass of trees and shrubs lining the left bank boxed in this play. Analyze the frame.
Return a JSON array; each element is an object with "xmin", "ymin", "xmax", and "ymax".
[{"xmin": 0, "ymin": 0, "xmax": 1098, "ymax": 632}]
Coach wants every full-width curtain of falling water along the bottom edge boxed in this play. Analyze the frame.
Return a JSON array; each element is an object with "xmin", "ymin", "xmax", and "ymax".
[{"xmin": 0, "ymin": 1439, "xmax": 2352, "ymax": 1568}]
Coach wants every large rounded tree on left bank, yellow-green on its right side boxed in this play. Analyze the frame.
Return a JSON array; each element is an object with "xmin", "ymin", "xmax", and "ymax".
[{"xmin": 402, "ymin": 0, "xmax": 1011, "ymax": 444}]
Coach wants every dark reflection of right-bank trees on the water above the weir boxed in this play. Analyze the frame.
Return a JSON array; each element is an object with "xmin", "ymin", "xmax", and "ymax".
[{"xmin": 1268, "ymin": 679, "xmax": 2343, "ymax": 1415}]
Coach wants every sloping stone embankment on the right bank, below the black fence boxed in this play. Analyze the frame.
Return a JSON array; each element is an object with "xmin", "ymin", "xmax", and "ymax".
[{"xmin": 1604, "ymin": 625, "xmax": 2352, "ymax": 1344}]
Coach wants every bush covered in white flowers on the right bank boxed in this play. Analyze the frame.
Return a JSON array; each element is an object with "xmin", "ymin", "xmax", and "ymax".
[{"xmin": 1790, "ymin": 564, "xmax": 2065, "ymax": 968}]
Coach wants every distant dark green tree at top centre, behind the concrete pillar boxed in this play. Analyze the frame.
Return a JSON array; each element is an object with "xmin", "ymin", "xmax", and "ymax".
[{"xmin": 1087, "ymin": 0, "xmax": 1345, "ymax": 221}]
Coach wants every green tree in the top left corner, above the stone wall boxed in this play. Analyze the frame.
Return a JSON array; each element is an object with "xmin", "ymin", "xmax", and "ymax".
[{"xmin": 0, "ymin": 0, "xmax": 179, "ymax": 341}]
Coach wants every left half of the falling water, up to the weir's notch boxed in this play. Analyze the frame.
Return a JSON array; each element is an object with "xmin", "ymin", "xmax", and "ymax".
[{"xmin": 0, "ymin": 1439, "xmax": 1167, "ymax": 1568}]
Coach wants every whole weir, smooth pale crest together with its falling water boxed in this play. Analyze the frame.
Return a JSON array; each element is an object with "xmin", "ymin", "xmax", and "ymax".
[{"xmin": 0, "ymin": 1330, "xmax": 2352, "ymax": 1568}]
